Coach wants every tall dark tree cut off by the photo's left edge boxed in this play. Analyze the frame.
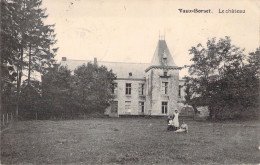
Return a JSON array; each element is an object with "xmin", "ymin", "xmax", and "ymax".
[{"xmin": 0, "ymin": 0, "xmax": 19, "ymax": 115}]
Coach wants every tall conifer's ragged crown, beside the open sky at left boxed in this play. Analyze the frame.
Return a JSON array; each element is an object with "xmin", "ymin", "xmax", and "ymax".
[{"xmin": 21, "ymin": 0, "xmax": 57, "ymax": 85}]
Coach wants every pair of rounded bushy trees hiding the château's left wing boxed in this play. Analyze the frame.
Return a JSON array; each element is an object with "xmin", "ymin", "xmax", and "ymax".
[{"xmin": 39, "ymin": 63, "xmax": 115, "ymax": 117}]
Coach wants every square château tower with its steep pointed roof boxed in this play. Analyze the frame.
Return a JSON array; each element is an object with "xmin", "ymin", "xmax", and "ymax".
[{"xmin": 145, "ymin": 37, "xmax": 179, "ymax": 116}]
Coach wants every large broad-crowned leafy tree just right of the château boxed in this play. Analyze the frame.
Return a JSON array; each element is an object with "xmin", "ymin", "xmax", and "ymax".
[{"xmin": 186, "ymin": 37, "xmax": 253, "ymax": 118}]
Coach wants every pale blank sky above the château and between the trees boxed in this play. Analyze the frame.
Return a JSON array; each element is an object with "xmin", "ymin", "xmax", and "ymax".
[{"xmin": 43, "ymin": 0, "xmax": 260, "ymax": 77}]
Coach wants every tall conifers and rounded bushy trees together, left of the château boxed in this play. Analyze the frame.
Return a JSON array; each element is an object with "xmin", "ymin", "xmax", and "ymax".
[{"xmin": 0, "ymin": 0, "xmax": 114, "ymax": 118}]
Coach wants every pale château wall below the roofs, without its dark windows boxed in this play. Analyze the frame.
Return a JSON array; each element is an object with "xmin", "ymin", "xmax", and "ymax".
[{"xmin": 104, "ymin": 69, "xmax": 184, "ymax": 117}]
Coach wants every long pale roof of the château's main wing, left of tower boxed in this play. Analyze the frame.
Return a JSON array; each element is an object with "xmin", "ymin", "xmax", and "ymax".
[{"xmin": 61, "ymin": 59, "xmax": 150, "ymax": 79}]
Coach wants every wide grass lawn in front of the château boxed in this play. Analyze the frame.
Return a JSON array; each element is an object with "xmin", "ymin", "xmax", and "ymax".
[{"xmin": 1, "ymin": 118, "xmax": 260, "ymax": 164}]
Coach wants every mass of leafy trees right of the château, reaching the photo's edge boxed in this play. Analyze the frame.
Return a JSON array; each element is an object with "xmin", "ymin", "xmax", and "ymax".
[{"xmin": 186, "ymin": 37, "xmax": 259, "ymax": 118}]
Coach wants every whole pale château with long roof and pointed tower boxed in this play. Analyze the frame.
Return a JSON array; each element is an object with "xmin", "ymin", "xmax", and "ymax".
[{"xmin": 61, "ymin": 40, "xmax": 184, "ymax": 117}]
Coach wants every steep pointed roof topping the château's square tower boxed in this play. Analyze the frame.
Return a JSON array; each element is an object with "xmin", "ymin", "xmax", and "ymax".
[{"xmin": 151, "ymin": 40, "xmax": 176, "ymax": 66}]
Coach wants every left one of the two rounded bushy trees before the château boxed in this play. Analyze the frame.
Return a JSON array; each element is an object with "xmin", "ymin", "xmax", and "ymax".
[{"xmin": 42, "ymin": 65, "xmax": 72, "ymax": 117}]
